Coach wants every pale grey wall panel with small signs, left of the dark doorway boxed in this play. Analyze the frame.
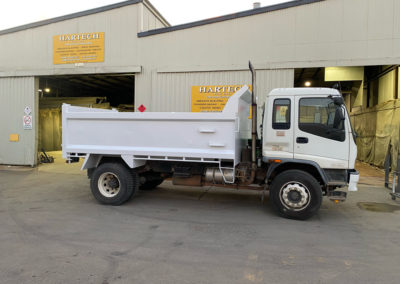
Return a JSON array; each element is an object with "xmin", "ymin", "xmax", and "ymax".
[{"xmin": 0, "ymin": 77, "xmax": 38, "ymax": 166}]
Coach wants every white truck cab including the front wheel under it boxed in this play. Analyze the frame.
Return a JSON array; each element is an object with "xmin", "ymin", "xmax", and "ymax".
[{"xmin": 261, "ymin": 88, "xmax": 358, "ymax": 220}]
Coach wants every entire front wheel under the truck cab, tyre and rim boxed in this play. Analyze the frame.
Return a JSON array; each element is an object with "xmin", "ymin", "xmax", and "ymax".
[{"xmin": 270, "ymin": 170, "xmax": 322, "ymax": 220}]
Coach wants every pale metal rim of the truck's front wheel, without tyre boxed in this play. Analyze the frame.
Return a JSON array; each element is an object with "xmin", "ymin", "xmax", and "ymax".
[{"xmin": 279, "ymin": 181, "xmax": 311, "ymax": 211}]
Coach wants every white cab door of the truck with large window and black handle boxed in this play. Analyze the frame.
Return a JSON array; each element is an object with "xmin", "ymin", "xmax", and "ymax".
[{"xmin": 294, "ymin": 95, "xmax": 349, "ymax": 169}]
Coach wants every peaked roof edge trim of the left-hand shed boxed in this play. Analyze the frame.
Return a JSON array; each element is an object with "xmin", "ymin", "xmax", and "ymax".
[{"xmin": 0, "ymin": 0, "xmax": 170, "ymax": 35}]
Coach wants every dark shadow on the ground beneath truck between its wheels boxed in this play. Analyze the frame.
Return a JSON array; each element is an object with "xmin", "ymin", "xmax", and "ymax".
[{"xmin": 123, "ymin": 182, "xmax": 318, "ymax": 222}]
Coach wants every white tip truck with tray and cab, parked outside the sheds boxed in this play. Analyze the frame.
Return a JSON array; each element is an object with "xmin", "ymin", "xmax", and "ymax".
[{"xmin": 62, "ymin": 63, "xmax": 359, "ymax": 219}]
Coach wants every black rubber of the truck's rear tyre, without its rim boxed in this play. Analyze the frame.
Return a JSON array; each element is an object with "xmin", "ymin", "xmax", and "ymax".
[{"xmin": 90, "ymin": 163, "xmax": 139, "ymax": 206}]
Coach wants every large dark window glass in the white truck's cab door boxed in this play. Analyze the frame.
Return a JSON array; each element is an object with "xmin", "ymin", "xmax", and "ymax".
[{"xmin": 299, "ymin": 98, "xmax": 346, "ymax": 141}]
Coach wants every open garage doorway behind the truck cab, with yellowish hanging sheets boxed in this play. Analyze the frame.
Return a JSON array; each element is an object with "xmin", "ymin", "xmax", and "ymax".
[{"xmin": 294, "ymin": 64, "xmax": 400, "ymax": 170}]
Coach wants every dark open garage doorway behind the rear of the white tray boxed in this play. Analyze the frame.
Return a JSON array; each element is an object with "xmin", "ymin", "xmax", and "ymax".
[{"xmin": 38, "ymin": 74, "xmax": 135, "ymax": 158}]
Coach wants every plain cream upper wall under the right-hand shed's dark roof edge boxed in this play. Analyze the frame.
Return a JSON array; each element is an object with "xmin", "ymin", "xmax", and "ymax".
[{"xmin": 138, "ymin": 0, "xmax": 400, "ymax": 75}]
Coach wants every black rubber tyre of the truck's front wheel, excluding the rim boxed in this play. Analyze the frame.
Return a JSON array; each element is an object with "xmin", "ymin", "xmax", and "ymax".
[{"xmin": 270, "ymin": 170, "xmax": 322, "ymax": 220}]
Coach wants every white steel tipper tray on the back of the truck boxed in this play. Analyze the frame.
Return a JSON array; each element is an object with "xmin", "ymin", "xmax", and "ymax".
[{"xmin": 62, "ymin": 87, "xmax": 250, "ymax": 164}]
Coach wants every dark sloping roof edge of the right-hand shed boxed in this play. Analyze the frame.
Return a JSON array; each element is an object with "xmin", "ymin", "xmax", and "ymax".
[{"xmin": 138, "ymin": 0, "xmax": 325, "ymax": 37}]
